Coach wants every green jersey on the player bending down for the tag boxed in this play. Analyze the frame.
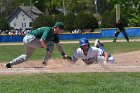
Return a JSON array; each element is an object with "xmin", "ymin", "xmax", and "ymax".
[{"xmin": 28, "ymin": 27, "xmax": 59, "ymax": 43}]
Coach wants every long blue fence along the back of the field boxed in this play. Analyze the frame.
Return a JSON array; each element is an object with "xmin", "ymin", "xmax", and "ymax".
[{"xmin": 0, "ymin": 28, "xmax": 140, "ymax": 42}]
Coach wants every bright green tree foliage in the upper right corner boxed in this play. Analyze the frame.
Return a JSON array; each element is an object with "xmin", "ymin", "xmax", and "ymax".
[{"xmin": 108, "ymin": 0, "xmax": 140, "ymax": 26}]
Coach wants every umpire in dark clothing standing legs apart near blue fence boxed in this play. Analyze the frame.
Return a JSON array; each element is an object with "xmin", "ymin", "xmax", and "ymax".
[{"xmin": 113, "ymin": 19, "xmax": 129, "ymax": 42}]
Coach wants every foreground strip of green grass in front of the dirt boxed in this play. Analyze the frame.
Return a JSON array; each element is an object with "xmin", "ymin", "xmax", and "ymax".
[{"xmin": 0, "ymin": 73, "xmax": 140, "ymax": 93}]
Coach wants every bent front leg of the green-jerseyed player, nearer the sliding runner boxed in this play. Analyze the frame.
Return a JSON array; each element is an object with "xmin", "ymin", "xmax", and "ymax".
[{"xmin": 42, "ymin": 41, "xmax": 54, "ymax": 65}]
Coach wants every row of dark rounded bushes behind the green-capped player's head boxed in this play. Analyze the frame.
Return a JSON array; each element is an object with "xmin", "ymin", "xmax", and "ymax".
[{"xmin": 33, "ymin": 13, "xmax": 98, "ymax": 32}]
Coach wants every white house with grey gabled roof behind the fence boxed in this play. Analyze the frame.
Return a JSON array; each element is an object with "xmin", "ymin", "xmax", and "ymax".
[{"xmin": 7, "ymin": 6, "xmax": 43, "ymax": 30}]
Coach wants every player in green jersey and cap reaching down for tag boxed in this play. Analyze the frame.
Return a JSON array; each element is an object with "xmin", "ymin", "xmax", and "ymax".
[{"xmin": 5, "ymin": 22, "xmax": 67, "ymax": 68}]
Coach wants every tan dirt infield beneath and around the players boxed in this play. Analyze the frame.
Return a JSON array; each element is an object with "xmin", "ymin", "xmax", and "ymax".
[{"xmin": 0, "ymin": 40, "xmax": 140, "ymax": 74}]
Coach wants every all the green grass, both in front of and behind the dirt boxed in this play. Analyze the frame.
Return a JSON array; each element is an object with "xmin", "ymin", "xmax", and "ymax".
[{"xmin": 0, "ymin": 42, "xmax": 140, "ymax": 93}]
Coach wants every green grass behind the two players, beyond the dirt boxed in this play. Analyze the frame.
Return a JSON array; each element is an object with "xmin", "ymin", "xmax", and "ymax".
[{"xmin": 0, "ymin": 42, "xmax": 140, "ymax": 62}]
